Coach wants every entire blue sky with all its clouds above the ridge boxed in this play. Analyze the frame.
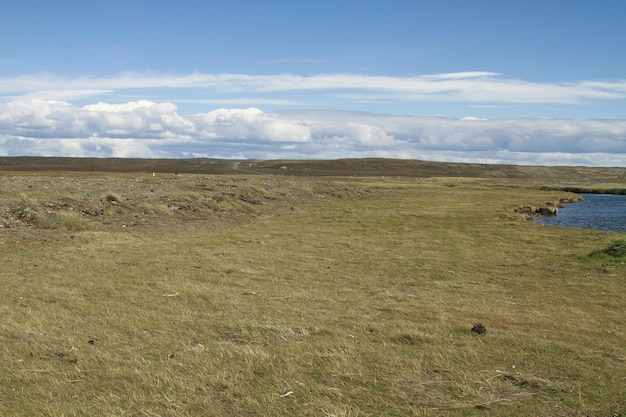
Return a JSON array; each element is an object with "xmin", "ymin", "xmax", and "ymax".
[{"xmin": 0, "ymin": 0, "xmax": 626, "ymax": 167}]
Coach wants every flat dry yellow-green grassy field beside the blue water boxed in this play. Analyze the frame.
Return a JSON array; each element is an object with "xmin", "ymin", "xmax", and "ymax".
[{"xmin": 0, "ymin": 172, "xmax": 626, "ymax": 417}]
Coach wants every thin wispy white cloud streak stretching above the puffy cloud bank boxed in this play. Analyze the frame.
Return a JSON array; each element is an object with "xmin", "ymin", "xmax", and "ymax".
[{"xmin": 0, "ymin": 71, "xmax": 626, "ymax": 104}]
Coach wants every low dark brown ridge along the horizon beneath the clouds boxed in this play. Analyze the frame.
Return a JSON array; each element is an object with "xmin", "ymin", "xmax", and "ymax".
[{"xmin": 0, "ymin": 156, "xmax": 626, "ymax": 183}]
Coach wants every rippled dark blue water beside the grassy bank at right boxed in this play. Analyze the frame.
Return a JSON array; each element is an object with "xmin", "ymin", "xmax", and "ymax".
[{"xmin": 535, "ymin": 194, "xmax": 626, "ymax": 232}]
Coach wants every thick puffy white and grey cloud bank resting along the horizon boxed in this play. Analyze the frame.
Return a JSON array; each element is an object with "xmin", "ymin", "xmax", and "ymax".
[{"xmin": 0, "ymin": 99, "xmax": 626, "ymax": 166}]
